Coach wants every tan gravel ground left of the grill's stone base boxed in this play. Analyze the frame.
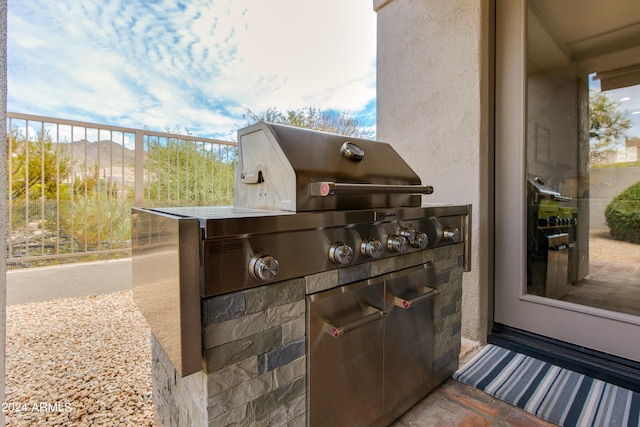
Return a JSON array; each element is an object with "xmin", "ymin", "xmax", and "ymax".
[{"xmin": 3, "ymin": 291, "xmax": 154, "ymax": 427}]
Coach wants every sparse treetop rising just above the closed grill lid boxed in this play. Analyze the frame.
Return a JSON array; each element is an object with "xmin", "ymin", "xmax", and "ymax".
[{"xmin": 244, "ymin": 107, "xmax": 374, "ymax": 139}]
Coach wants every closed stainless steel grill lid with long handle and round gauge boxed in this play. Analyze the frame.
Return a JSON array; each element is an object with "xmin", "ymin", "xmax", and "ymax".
[{"xmin": 234, "ymin": 122, "xmax": 433, "ymax": 212}]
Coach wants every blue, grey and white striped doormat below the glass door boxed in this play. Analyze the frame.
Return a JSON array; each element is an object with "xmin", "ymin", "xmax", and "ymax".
[{"xmin": 453, "ymin": 344, "xmax": 640, "ymax": 427}]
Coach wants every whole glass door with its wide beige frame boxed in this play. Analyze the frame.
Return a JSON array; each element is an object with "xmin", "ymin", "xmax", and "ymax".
[{"xmin": 495, "ymin": 0, "xmax": 640, "ymax": 360}]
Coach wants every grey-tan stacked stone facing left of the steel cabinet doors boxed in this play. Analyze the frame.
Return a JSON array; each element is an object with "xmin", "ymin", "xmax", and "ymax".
[{"xmin": 202, "ymin": 279, "xmax": 306, "ymax": 426}]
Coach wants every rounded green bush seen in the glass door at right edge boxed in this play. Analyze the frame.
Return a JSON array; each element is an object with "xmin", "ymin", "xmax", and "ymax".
[{"xmin": 604, "ymin": 181, "xmax": 640, "ymax": 243}]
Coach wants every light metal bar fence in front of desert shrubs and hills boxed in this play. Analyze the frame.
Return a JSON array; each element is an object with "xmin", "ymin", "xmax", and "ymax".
[{"xmin": 6, "ymin": 113, "xmax": 237, "ymax": 268}]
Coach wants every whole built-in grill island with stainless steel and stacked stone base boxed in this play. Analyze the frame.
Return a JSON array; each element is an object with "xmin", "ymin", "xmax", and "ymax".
[{"xmin": 133, "ymin": 123, "xmax": 471, "ymax": 426}]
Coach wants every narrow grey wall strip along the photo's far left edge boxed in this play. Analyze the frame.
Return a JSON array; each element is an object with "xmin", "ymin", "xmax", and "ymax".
[{"xmin": 0, "ymin": 0, "xmax": 7, "ymax": 427}]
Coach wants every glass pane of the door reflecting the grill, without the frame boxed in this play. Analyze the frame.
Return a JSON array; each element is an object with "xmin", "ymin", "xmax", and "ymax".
[{"xmin": 525, "ymin": 0, "xmax": 640, "ymax": 315}]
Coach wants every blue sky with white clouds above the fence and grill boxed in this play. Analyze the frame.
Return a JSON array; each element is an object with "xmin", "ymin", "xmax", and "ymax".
[{"xmin": 7, "ymin": 0, "xmax": 376, "ymax": 140}]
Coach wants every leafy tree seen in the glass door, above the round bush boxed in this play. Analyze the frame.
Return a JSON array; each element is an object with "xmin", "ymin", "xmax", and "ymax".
[{"xmin": 589, "ymin": 91, "xmax": 632, "ymax": 161}]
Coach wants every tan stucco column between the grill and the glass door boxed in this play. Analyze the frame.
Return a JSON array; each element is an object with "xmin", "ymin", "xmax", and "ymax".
[{"xmin": 373, "ymin": 0, "xmax": 493, "ymax": 342}]
